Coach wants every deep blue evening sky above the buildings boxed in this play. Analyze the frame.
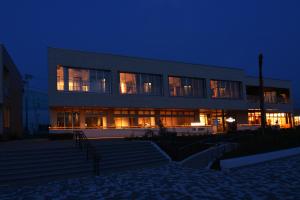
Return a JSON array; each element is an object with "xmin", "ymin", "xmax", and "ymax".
[{"xmin": 0, "ymin": 0, "xmax": 300, "ymax": 107}]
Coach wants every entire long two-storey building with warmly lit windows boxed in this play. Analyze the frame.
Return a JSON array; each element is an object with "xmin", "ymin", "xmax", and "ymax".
[{"xmin": 48, "ymin": 48, "xmax": 293, "ymax": 134}]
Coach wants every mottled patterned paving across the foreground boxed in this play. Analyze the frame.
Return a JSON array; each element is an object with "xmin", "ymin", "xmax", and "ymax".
[{"xmin": 0, "ymin": 156, "xmax": 300, "ymax": 200}]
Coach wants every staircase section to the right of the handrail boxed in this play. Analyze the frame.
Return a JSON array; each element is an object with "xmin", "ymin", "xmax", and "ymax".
[{"xmin": 92, "ymin": 140, "xmax": 169, "ymax": 175}]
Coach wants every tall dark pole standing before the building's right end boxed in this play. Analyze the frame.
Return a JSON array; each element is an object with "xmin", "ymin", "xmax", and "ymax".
[{"xmin": 258, "ymin": 54, "xmax": 266, "ymax": 134}]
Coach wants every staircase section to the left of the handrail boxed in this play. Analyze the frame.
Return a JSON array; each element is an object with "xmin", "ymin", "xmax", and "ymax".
[{"xmin": 0, "ymin": 145, "xmax": 93, "ymax": 187}]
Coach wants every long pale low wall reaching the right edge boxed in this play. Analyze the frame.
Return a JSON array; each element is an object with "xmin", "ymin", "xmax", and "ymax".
[{"xmin": 220, "ymin": 147, "xmax": 300, "ymax": 169}]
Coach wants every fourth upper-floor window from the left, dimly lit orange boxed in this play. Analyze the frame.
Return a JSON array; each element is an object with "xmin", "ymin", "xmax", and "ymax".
[{"xmin": 210, "ymin": 80, "xmax": 242, "ymax": 99}]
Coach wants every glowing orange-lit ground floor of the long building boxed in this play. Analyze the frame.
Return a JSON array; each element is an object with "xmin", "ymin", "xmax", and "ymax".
[{"xmin": 50, "ymin": 107, "xmax": 293, "ymax": 133}]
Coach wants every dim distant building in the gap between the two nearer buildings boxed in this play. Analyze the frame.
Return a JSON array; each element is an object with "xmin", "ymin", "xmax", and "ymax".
[{"xmin": 23, "ymin": 89, "xmax": 49, "ymax": 134}]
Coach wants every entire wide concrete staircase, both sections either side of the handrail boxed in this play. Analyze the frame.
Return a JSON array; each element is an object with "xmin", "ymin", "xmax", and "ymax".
[{"xmin": 0, "ymin": 139, "xmax": 169, "ymax": 189}]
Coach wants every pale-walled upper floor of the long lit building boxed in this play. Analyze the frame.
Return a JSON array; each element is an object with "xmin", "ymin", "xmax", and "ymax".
[{"xmin": 48, "ymin": 48, "xmax": 291, "ymax": 109}]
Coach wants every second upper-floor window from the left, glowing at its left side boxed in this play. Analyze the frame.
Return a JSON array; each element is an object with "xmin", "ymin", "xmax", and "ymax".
[{"xmin": 120, "ymin": 72, "xmax": 162, "ymax": 95}]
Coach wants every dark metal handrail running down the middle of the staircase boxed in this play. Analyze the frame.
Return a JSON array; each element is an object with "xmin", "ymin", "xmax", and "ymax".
[{"xmin": 74, "ymin": 130, "xmax": 100, "ymax": 176}]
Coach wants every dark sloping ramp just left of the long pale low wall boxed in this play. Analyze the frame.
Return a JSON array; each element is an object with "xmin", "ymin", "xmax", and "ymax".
[{"xmin": 180, "ymin": 143, "xmax": 238, "ymax": 168}]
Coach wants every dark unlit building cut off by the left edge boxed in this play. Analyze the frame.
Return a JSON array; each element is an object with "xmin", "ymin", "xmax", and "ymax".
[{"xmin": 0, "ymin": 44, "xmax": 23, "ymax": 137}]
